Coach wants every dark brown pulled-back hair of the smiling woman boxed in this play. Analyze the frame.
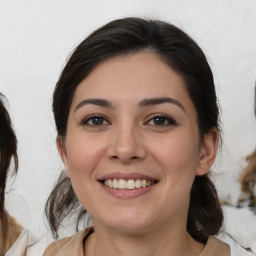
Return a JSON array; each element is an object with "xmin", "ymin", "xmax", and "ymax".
[{"xmin": 45, "ymin": 17, "xmax": 223, "ymax": 242}]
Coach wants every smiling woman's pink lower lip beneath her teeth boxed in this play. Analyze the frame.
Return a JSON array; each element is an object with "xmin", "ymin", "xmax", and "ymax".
[{"xmin": 100, "ymin": 182, "xmax": 156, "ymax": 199}]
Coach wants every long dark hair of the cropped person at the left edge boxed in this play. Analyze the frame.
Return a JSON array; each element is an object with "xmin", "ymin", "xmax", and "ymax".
[{"xmin": 0, "ymin": 93, "xmax": 18, "ymax": 244}]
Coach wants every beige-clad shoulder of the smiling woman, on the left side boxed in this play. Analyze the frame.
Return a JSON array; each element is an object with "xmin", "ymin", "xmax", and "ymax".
[{"xmin": 43, "ymin": 228, "xmax": 93, "ymax": 256}]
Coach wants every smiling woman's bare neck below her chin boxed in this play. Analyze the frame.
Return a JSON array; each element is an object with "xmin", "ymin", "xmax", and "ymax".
[{"xmin": 85, "ymin": 220, "xmax": 204, "ymax": 256}]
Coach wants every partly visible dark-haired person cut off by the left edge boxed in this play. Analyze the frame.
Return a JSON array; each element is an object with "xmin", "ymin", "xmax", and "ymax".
[{"xmin": 0, "ymin": 93, "xmax": 34, "ymax": 256}]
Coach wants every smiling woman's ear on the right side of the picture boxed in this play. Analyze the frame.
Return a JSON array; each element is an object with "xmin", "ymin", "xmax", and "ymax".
[{"xmin": 196, "ymin": 128, "xmax": 218, "ymax": 176}]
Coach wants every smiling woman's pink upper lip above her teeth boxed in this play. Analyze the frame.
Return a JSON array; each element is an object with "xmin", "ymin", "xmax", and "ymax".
[{"xmin": 98, "ymin": 172, "xmax": 158, "ymax": 181}]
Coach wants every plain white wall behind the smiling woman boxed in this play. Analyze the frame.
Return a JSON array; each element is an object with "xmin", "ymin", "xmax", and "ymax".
[{"xmin": 0, "ymin": 0, "xmax": 256, "ymax": 244}]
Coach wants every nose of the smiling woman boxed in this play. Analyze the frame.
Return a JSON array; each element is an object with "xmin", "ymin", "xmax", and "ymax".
[{"xmin": 108, "ymin": 122, "xmax": 146, "ymax": 163}]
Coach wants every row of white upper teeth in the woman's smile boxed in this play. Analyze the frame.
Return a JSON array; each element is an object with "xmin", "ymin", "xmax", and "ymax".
[{"xmin": 104, "ymin": 179, "xmax": 154, "ymax": 189}]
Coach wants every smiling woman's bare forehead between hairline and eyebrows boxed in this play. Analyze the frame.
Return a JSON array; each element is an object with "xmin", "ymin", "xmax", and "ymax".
[{"xmin": 73, "ymin": 52, "xmax": 193, "ymax": 105}]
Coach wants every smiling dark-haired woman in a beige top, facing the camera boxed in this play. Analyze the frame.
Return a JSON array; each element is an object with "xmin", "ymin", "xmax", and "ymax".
[{"xmin": 44, "ymin": 18, "xmax": 230, "ymax": 256}]
